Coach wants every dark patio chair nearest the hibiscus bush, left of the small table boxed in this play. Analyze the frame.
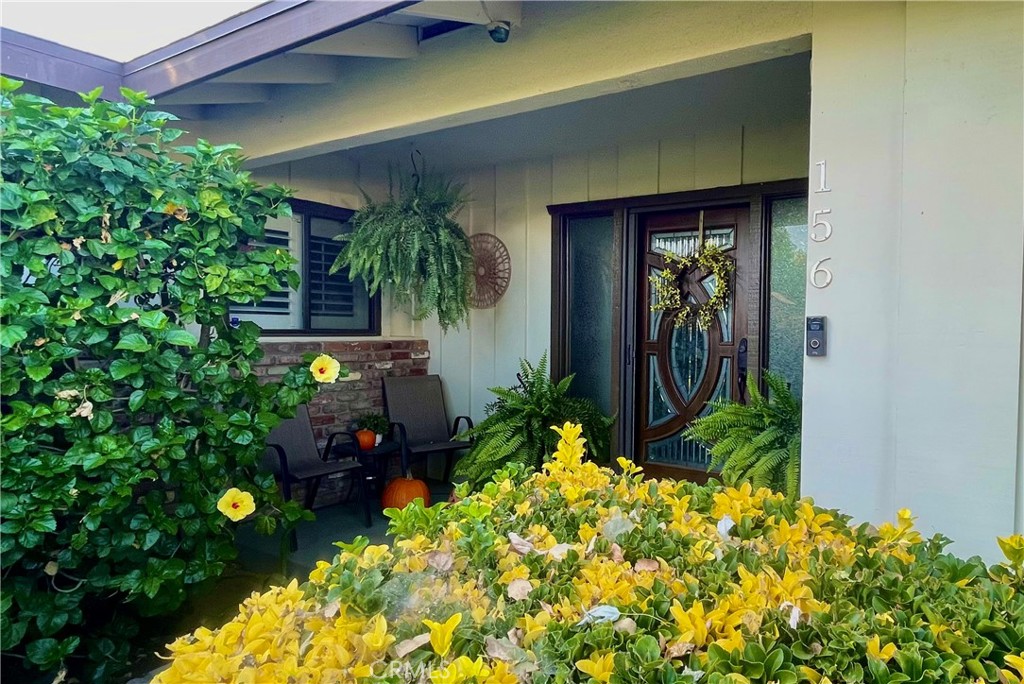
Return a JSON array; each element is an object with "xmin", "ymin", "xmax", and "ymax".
[{"xmin": 263, "ymin": 404, "xmax": 373, "ymax": 532}]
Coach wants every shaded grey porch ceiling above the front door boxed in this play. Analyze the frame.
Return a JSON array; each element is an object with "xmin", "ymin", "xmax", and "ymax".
[{"xmin": 336, "ymin": 52, "xmax": 810, "ymax": 175}]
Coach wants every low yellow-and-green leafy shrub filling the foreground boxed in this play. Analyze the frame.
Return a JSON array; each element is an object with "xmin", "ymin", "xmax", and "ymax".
[{"xmin": 156, "ymin": 424, "xmax": 1024, "ymax": 684}]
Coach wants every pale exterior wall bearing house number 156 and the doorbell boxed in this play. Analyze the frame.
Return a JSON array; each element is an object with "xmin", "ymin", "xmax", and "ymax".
[{"xmin": 803, "ymin": 2, "xmax": 1024, "ymax": 558}]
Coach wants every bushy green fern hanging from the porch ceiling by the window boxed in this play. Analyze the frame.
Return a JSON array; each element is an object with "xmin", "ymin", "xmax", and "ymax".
[{"xmin": 331, "ymin": 157, "xmax": 473, "ymax": 331}]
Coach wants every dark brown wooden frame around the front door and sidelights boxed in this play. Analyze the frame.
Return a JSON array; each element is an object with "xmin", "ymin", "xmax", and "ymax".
[{"xmin": 548, "ymin": 178, "xmax": 808, "ymax": 459}]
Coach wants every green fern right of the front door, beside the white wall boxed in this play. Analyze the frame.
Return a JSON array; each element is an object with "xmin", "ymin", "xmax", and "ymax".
[{"xmin": 683, "ymin": 371, "xmax": 801, "ymax": 500}]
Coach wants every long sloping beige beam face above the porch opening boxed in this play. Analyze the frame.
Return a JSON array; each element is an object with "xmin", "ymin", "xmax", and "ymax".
[{"xmin": 182, "ymin": 2, "xmax": 811, "ymax": 166}]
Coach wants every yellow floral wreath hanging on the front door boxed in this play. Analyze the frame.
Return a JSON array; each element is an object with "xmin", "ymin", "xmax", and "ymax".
[{"xmin": 650, "ymin": 242, "xmax": 735, "ymax": 330}]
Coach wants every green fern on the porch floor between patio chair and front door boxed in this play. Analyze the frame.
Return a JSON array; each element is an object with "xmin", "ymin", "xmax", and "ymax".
[{"xmin": 455, "ymin": 353, "xmax": 614, "ymax": 488}]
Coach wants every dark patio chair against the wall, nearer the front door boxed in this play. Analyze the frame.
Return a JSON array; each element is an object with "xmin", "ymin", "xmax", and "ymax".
[{"xmin": 384, "ymin": 375, "xmax": 473, "ymax": 482}]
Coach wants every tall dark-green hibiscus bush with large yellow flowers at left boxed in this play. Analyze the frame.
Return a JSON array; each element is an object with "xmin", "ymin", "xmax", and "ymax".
[{"xmin": 0, "ymin": 79, "xmax": 331, "ymax": 681}]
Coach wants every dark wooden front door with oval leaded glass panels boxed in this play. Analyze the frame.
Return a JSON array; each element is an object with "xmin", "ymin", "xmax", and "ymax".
[{"xmin": 633, "ymin": 205, "xmax": 760, "ymax": 482}]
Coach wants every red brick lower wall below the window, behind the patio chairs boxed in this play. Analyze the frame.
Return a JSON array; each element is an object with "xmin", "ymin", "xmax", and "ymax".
[{"xmin": 260, "ymin": 340, "xmax": 430, "ymax": 506}]
